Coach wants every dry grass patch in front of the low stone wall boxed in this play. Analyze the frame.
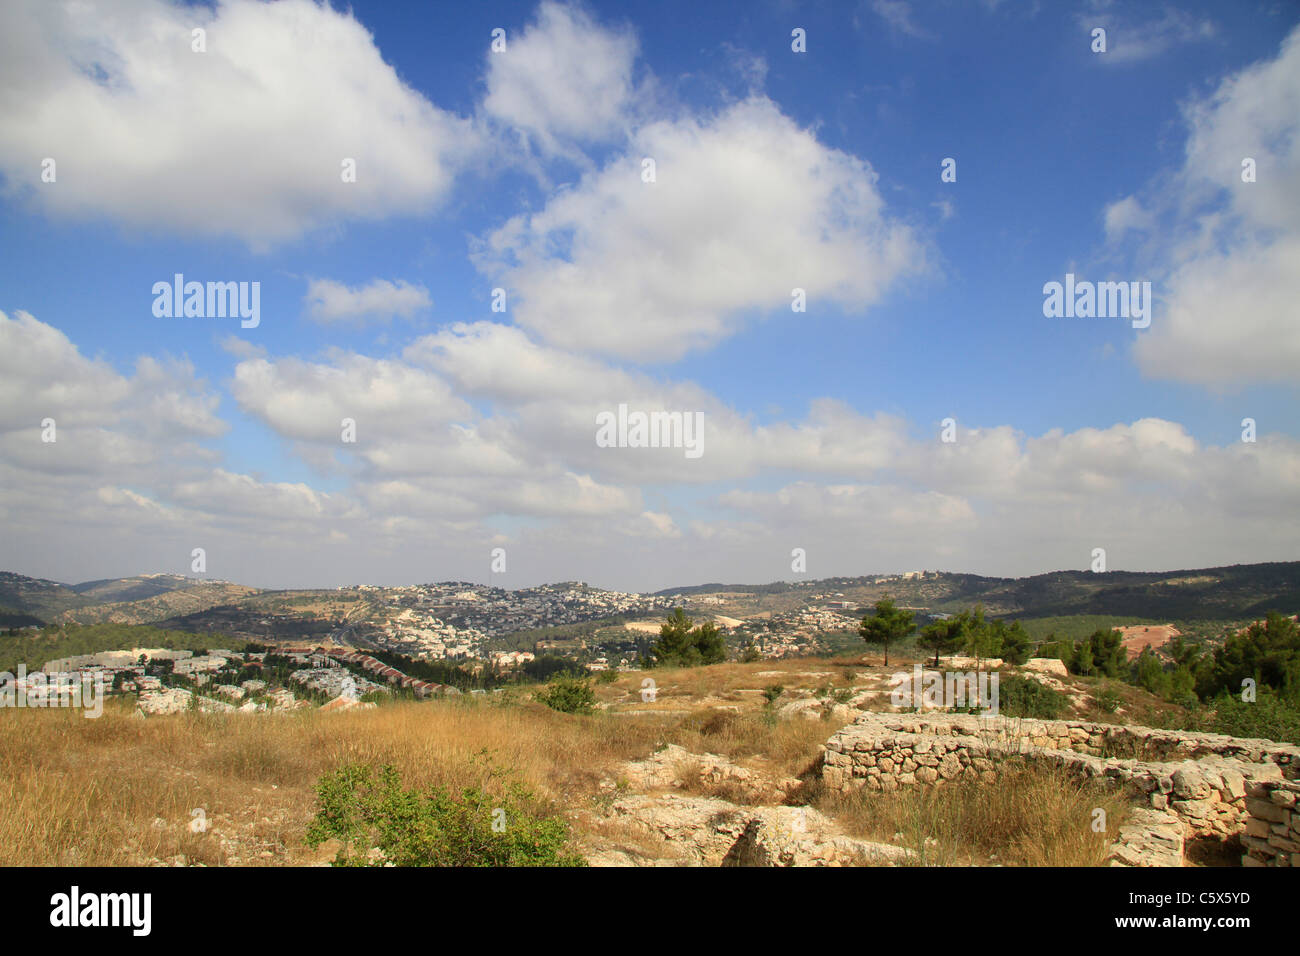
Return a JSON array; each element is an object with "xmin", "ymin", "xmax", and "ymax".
[{"xmin": 814, "ymin": 766, "xmax": 1128, "ymax": 866}]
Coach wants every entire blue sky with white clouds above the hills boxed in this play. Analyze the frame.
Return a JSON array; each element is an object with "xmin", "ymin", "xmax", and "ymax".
[{"xmin": 0, "ymin": 0, "xmax": 1300, "ymax": 592}]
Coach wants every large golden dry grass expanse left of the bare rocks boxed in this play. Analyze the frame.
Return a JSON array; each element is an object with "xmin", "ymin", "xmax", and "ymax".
[{"xmin": 0, "ymin": 686, "xmax": 828, "ymax": 866}]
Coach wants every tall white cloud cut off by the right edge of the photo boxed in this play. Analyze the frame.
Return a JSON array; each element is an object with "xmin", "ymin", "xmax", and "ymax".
[{"xmin": 1123, "ymin": 27, "xmax": 1300, "ymax": 386}]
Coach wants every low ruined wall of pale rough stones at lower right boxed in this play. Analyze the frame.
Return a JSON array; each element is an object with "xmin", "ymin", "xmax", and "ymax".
[{"xmin": 822, "ymin": 713, "xmax": 1300, "ymax": 866}]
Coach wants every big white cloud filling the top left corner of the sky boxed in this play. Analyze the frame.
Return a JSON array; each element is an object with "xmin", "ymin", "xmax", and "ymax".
[{"xmin": 0, "ymin": 0, "xmax": 478, "ymax": 248}]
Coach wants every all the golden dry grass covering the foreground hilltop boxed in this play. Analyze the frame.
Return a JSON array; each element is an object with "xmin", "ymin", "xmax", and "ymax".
[{"xmin": 0, "ymin": 658, "xmax": 1149, "ymax": 866}]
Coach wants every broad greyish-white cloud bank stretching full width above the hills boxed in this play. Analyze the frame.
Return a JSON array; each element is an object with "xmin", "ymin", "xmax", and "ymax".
[{"xmin": 0, "ymin": 308, "xmax": 1300, "ymax": 588}]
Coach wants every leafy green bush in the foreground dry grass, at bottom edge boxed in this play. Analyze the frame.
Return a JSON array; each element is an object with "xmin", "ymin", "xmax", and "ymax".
[{"xmin": 307, "ymin": 763, "xmax": 586, "ymax": 866}]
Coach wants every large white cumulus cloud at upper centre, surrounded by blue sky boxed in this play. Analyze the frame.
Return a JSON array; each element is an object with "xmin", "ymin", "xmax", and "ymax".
[{"xmin": 476, "ymin": 98, "xmax": 926, "ymax": 362}]
